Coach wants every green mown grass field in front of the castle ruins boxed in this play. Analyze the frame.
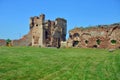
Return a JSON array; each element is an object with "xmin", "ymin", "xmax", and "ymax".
[{"xmin": 0, "ymin": 47, "xmax": 120, "ymax": 80}]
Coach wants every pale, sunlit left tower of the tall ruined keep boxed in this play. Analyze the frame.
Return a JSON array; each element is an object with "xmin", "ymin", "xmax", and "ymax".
[{"xmin": 30, "ymin": 14, "xmax": 45, "ymax": 46}]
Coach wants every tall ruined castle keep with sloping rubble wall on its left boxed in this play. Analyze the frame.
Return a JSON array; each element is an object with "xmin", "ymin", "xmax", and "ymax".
[{"xmin": 12, "ymin": 14, "xmax": 67, "ymax": 47}]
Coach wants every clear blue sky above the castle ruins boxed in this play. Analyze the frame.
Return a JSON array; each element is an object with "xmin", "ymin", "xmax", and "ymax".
[{"xmin": 0, "ymin": 0, "xmax": 120, "ymax": 39}]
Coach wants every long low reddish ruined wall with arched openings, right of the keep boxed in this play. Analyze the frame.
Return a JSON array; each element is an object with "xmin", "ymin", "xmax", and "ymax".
[{"xmin": 67, "ymin": 24, "xmax": 120, "ymax": 48}]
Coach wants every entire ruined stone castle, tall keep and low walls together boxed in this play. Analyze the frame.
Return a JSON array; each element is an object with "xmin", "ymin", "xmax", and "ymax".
[{"xmin": 0, "ymin": 14, "xmax": 120, "ymax": 49}]
